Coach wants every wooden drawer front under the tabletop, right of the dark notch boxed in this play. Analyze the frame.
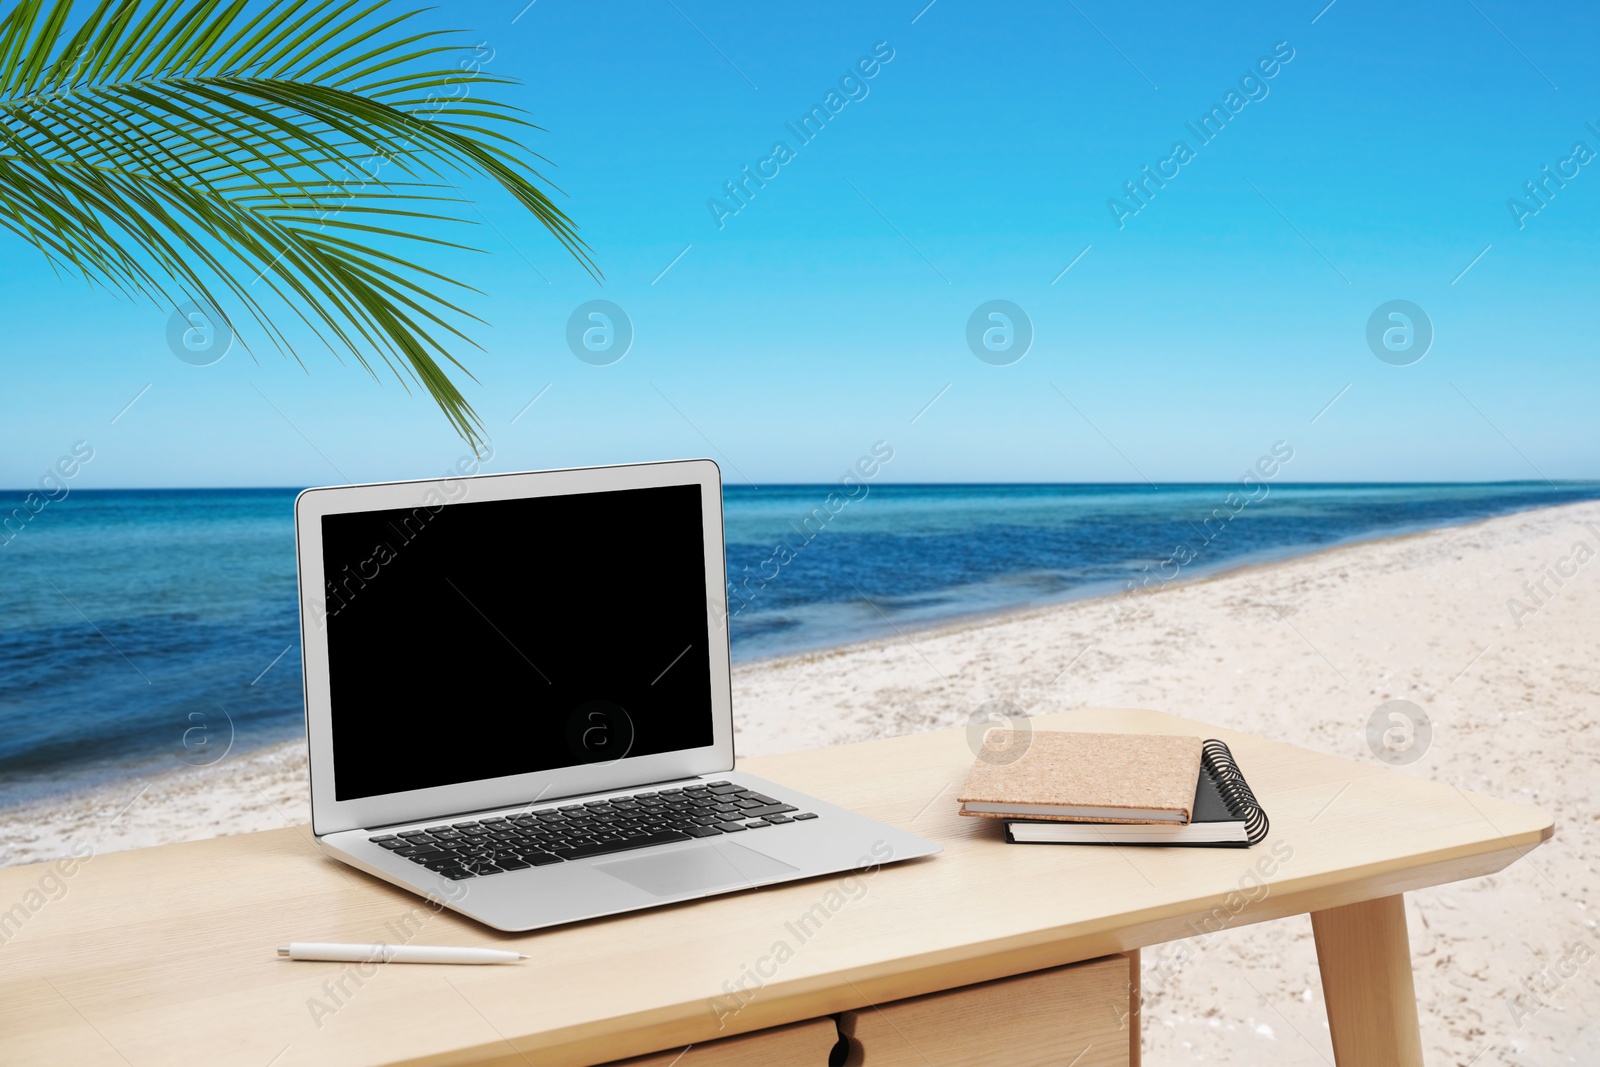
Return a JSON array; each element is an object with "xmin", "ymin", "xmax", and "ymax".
[{"xmin": 838, "ymin": 955, "xmax": 1139, "ymax": 1067}]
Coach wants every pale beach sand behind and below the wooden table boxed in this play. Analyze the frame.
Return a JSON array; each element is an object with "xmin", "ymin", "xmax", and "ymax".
[{"xmin": 0, "ymin": 504, "xmax": 1600, "ymax": 1067}]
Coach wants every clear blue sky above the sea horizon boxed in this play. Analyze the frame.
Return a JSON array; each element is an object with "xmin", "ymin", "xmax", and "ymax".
[{"xmin": 0, "ymin": 0, "xmax": 1600, "ymax": 486}]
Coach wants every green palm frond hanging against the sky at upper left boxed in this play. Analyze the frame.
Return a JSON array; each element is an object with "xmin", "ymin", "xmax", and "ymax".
[{"xmin": 0, "ymin": 0, "xmax": 598, "ymax": 442}]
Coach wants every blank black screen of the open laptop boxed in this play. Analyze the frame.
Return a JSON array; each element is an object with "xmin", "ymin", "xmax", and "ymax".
[{"xmin": 322, "ymin": 485, "xmax": 720, "ymax": 801}]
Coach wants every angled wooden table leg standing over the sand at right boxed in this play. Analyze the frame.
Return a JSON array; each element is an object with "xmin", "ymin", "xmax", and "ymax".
[{"xmin": 1310, "ymin": 894, "xmax": 1422, "ymax": 1067}]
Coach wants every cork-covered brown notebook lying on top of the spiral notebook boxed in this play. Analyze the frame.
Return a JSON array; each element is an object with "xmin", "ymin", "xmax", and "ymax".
[{"xmin": 957, "ymin": 728, "xmax": 1203, "ymax": 824}]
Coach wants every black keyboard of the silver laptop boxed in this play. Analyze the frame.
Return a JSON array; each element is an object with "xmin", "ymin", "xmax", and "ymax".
[{"xmin": 368, "ymin": 782, "xmax": 816, "ymax": 881}]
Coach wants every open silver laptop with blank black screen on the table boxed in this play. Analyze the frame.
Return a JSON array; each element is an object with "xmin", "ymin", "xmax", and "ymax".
[{"xmin": 294, "ymin": 459, "xmax": 939, "ymax": 931}]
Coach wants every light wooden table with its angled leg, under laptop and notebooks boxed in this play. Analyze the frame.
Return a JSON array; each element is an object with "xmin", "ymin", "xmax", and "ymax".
[{"xmin": 0, "ymin": 710, "xmax": 1552, "ymax": 1067}]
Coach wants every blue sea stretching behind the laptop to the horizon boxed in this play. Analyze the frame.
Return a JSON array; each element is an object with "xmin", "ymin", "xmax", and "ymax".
[{"xmin": 0, "ymin": 480, "xmax": 1600, "ymax": 806}]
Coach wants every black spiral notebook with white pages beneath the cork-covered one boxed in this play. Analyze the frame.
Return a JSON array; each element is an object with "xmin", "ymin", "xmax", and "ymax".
[{"xmin": 1005, "ymin": 741, "xmax": 1270, "ymax": 848}]
